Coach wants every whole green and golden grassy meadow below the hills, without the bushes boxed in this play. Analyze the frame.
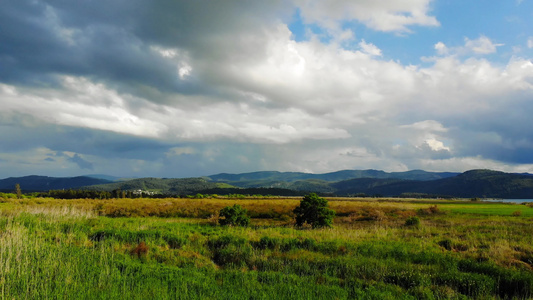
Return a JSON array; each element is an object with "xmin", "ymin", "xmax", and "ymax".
[{"xmin": 0, "ymin": 198, "xmax": 533, "ymax": 299}]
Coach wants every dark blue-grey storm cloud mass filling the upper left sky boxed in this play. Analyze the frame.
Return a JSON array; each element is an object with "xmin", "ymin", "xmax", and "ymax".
[{"xmin": 0, "ymin": 0, "xmax": 284, "ymax": 101}]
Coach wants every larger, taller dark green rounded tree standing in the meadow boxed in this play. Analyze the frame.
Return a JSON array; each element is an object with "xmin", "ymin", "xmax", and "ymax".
[{"xmin": 293, "ymin": 193, "xmax": 335, "ymax": 228}]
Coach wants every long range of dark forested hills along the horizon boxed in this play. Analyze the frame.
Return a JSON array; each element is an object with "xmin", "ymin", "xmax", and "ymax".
[{"xmin": 0, "ymin": 170, "xmax": 533, "ymax": 199}]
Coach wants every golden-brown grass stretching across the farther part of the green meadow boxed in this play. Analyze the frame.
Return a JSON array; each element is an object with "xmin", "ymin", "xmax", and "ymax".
[{"xmin": 0, "ymin": 198, "xmax": 533, "ymax": 292}]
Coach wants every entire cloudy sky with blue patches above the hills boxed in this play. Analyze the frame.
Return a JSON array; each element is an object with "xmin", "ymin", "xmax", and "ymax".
[{"xmin": 0, "ymin": 0, "xmax": 533, "ymax": 178}]
